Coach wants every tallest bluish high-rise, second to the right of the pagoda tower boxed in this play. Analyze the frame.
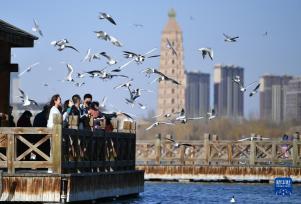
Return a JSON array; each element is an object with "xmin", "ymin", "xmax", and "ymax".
[{"xmin": 214, "ymin": 64, "xmax": 244, "ymax": 119}]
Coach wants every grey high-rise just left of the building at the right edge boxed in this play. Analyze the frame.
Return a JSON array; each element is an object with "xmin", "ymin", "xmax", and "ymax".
[{"xmin": 259, "ymin": 75, "xmax": 292, "ymax": 123}]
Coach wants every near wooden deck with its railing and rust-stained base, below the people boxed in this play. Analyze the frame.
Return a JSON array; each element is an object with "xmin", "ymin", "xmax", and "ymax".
[{"xmin": 0, "ymin": 115, "xmax": 144, "ymax": 202}]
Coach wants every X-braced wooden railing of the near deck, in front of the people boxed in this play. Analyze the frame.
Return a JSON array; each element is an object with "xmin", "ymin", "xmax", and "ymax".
[{"xmin": 0, "ymin": 116, "xmax": 136, "ymax": 174}]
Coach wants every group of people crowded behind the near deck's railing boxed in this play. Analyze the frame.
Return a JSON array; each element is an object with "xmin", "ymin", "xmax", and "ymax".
[{"xmin": 0, "ymin": 93, "xmax": 119, "ymax": 131}]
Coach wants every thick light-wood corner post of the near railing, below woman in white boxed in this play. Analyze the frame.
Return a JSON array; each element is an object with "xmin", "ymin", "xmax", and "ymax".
[{"xmin": 50, "ymin": 114, "xmax": 62, "ymax": 174}]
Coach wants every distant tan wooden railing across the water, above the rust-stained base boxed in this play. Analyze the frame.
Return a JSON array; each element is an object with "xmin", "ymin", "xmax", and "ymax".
[{"xmin": 136, "ymin": 134, "xmax": 301, "ymax": 167}]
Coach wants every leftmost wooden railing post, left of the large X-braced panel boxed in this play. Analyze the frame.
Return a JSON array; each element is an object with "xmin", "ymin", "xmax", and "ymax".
[{"xmin": 6, "ymin": 134, "xmax": 16, "ymax": 174}]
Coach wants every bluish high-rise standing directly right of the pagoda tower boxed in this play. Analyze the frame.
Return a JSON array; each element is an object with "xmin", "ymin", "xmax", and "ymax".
[{"xmin": 185, "ymin": 72, "xmax": 210, "ymax": 117}]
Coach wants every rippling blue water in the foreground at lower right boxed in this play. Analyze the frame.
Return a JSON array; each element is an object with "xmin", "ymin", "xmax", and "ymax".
[{"xmin": 103, "ymin": 182, "xmax": 301, "ymax": 204}]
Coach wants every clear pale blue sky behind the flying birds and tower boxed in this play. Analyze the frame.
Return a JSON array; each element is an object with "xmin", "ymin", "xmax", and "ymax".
[{"xmin": 0, "ymin": 0, "xmax": 301, "ymax": 116}]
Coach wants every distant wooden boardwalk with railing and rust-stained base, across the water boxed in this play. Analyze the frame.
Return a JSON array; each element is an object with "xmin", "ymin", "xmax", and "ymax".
[{"xmin": 136, "ymin": 134, "xmax": 301, "ymax": 182}]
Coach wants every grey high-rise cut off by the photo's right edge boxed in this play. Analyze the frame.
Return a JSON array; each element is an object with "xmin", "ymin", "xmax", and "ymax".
[{"xmin": 285, "ymin": 77, "xmax": 301, "ymax": 121}]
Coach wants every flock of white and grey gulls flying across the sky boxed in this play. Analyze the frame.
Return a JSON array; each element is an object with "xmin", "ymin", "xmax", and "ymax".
[{"xmin": 19, "ymin": 12, "xmax": 260, "ymax": 133}]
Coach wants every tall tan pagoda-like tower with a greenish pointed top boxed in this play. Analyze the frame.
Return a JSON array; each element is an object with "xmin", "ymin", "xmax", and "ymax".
[{"xmin": 157, "ymin": 9, "xmax": 185, "ymax": 114}]
